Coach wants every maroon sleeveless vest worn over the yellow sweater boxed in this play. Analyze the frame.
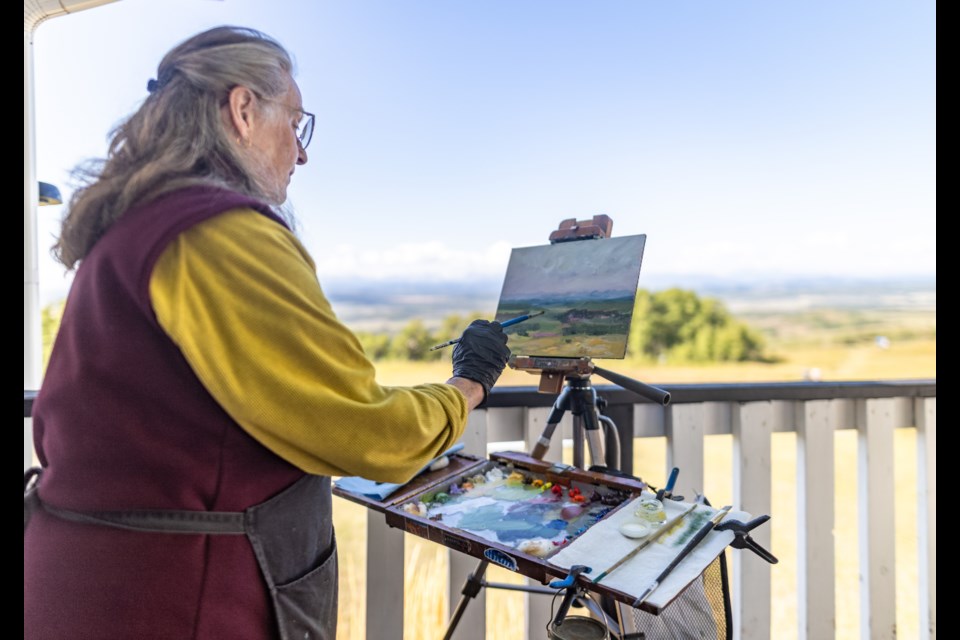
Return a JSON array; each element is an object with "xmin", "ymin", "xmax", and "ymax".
[{"xmin": 24, "ymin": 187, "xmax": 303, "ymax": 638}]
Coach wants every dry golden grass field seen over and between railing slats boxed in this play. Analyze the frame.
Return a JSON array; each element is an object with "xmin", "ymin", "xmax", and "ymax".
[{"xmin": 334, "ymin": 340, "xmax": 936, "ymax": 640}]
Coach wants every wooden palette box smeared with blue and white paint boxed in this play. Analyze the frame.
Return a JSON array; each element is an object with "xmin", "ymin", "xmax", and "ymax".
[{"xmin": 334, "ymin": 452, "xmax": 646, "ymax": 583}]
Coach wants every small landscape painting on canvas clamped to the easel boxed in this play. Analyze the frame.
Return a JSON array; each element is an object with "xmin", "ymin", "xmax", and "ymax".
[{"xmin": 496, "ymin": 235, "xmax": 646, "ymax": 358}]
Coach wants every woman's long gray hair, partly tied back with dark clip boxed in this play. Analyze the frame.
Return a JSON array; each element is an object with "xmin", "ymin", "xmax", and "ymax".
[{"xmin": 52, "ymin": 26, "xmax": 293, "ymax": 270}]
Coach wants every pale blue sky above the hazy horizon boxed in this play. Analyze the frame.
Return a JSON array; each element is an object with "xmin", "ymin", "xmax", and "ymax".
[{"xmin": 34, "ymin": 0, "xmax": 936, "ymax": 303}]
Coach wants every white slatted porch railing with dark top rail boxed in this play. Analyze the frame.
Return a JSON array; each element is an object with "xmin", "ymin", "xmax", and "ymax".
[{"xmin": 356, "ymin": 381, "xmax": 937, "ymax": 640}]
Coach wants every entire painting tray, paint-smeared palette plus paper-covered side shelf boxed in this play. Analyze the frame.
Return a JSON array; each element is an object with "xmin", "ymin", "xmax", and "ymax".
[{"xmin": 334, "ymin": 452, "xmax": 749, "ymax": 615}]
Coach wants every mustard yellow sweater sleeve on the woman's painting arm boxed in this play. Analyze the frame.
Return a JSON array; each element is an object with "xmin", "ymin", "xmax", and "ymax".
[{"xmin": 150, "ymin": 209, "xmax": 467, "ymax": 482}]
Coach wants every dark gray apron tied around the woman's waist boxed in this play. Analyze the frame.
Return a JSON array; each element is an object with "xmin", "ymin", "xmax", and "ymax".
[{"xmin": 23, "ymin": 468, "xmax": 337, "ymax": 640}]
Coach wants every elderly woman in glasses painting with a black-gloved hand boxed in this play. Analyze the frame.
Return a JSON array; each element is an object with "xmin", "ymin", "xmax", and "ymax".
[{"xmin": 23, "ymin": 27, "xmax": 509, "ymax": 640}]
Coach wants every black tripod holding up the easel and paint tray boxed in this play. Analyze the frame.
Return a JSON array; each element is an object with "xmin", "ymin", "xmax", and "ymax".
[{"xmin": 444, "ymin": 356, "xmax": 670, "ymax": 640}]
